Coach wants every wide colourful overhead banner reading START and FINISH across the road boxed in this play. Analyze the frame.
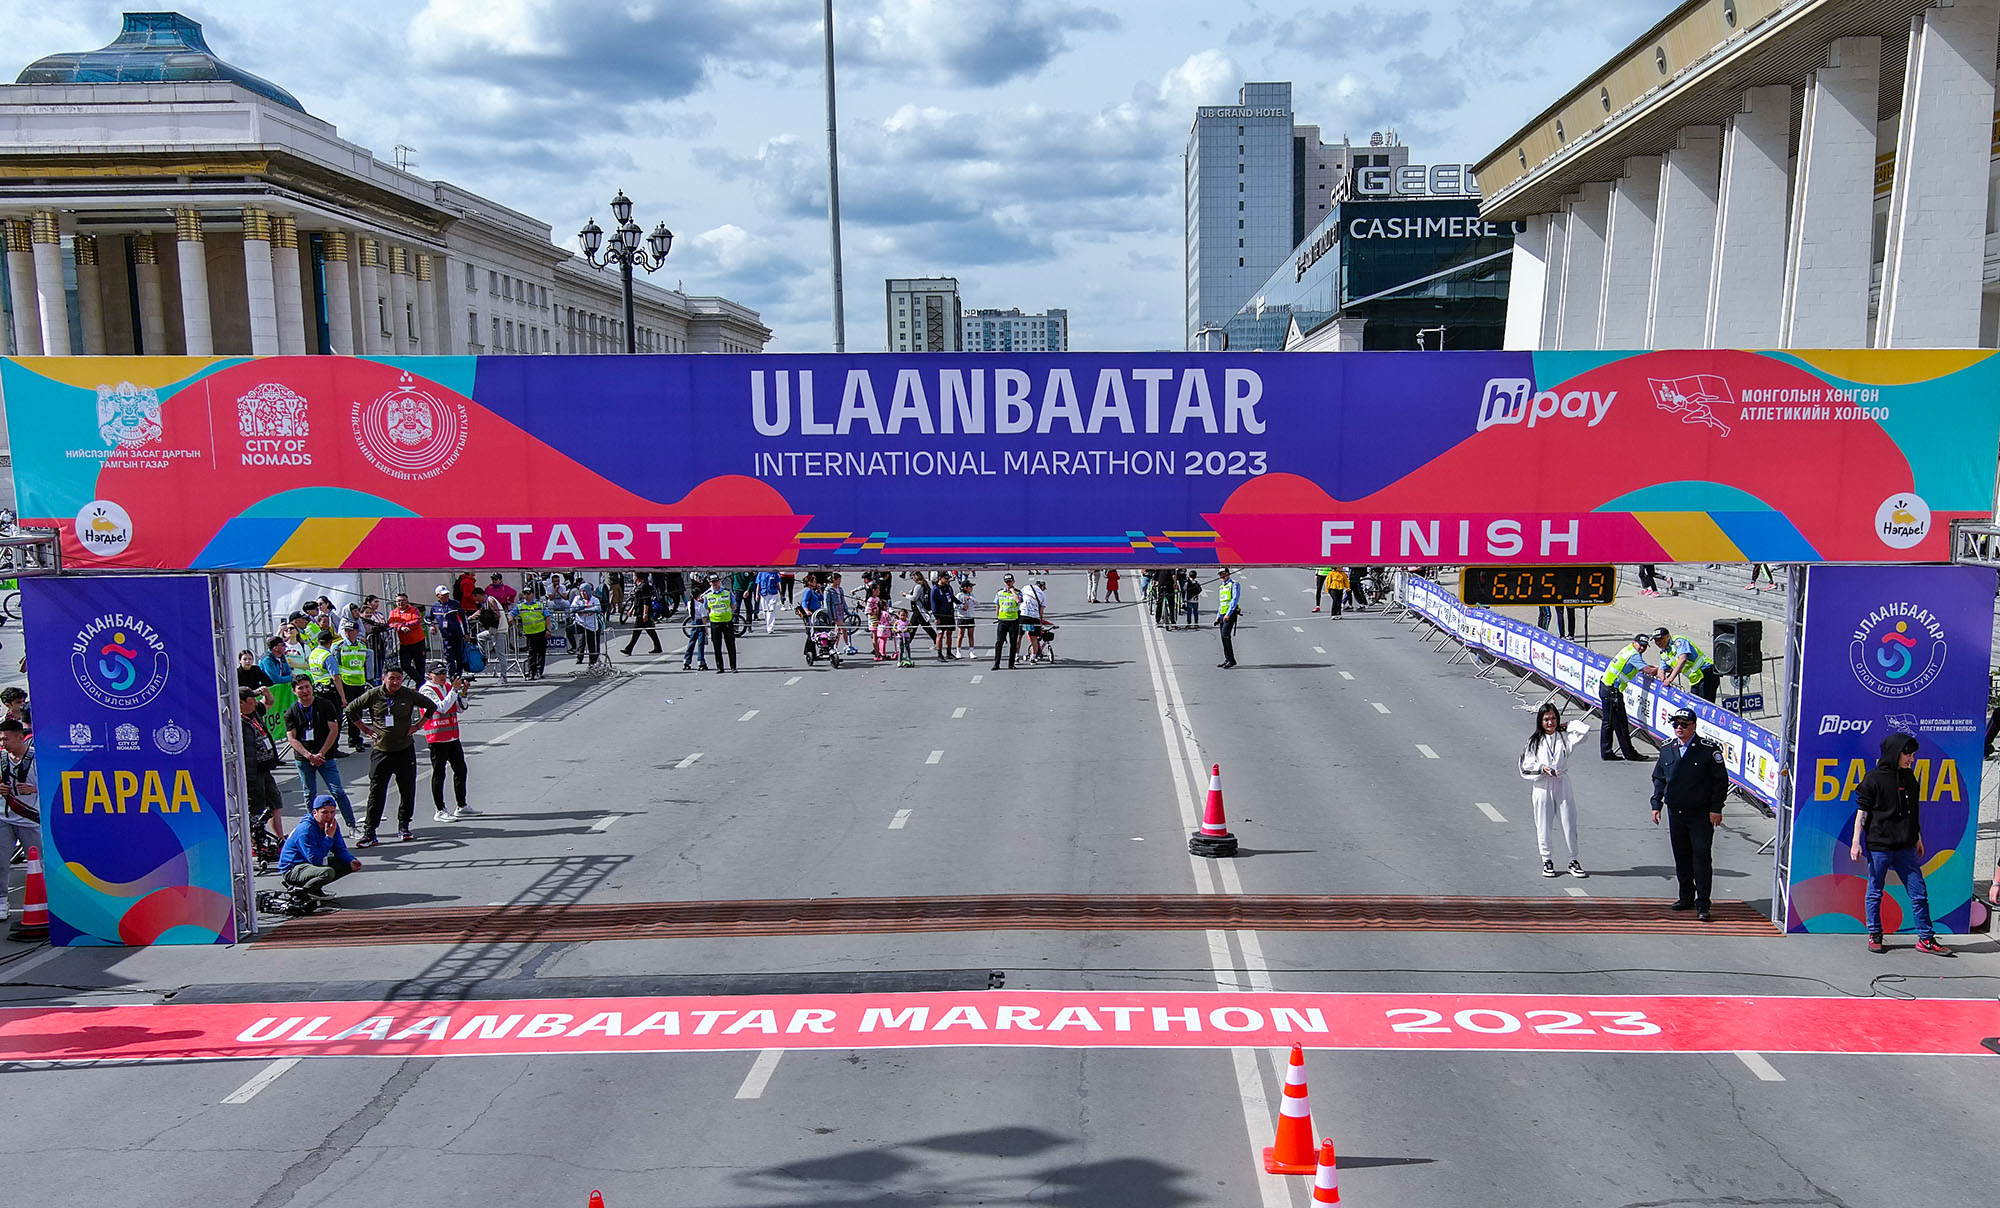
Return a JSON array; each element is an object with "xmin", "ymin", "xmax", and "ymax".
[{"xmin": 0, "ymin": 350, "xmax": 2000, "ymax": 570}]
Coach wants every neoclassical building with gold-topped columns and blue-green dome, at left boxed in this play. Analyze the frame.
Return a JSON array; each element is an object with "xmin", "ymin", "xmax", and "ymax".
[{"xmin": 0, "ymin": 12, "xmax": 770, "ymax": 356}]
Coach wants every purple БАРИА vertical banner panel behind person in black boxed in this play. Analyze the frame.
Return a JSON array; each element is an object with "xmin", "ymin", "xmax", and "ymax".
[{"xmin": 1786, "ymin": 566, "xmax": 1994, "ymax": 932}]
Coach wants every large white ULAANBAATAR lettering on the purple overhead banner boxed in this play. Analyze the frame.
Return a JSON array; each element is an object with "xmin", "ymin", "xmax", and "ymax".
[{"xmin": 750, "ymin": 362, "xmax": 1264, "ymax": 436}]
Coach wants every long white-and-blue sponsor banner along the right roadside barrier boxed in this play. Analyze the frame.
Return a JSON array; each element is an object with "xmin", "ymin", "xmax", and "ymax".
[{"xmin": 1404, "ymin": 576, "xmax": 1784, "ymax": 808}]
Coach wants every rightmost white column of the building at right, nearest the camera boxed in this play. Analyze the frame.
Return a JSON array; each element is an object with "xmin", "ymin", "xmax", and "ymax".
[{"xmin": 1876, "ymin": 0, "xmax": 2000, "ymax": 348}]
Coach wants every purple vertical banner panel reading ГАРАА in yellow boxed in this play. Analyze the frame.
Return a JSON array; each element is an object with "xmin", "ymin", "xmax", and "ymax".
[{"xmin": 20, "ymin": 576, "xmax": 236, "ymax": 946}]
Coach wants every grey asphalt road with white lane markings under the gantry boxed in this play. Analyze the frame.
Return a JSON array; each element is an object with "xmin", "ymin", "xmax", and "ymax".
[{"xmin": 0, "ymin": 570, "xmax": 2000, "ymax": 1208}]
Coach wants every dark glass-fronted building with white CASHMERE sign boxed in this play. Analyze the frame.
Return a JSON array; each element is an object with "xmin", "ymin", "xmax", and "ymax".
[{"xmin": 1224, "ymin": 198, "xmax": 1516, "ymax": 352}]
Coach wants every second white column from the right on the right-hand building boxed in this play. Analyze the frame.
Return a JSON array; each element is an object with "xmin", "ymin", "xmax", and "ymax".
[{"xmin": 1778, "ymin": 38, "xmax": 1882, "ymax": 348}]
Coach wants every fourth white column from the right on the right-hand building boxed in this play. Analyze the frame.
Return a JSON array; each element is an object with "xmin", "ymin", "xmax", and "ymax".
[{"xmin": 1646, "ymin": 126, "xmax": 1722, "ymax": 348}]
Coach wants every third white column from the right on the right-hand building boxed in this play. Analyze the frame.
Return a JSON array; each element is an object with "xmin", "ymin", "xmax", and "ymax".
[{"xmin": 1702, "ymin": 84, "xmax": 1800, "ymax": 348}]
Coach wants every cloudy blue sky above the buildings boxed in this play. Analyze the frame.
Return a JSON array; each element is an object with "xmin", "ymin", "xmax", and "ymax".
[{"xmin": 0, "ymin": 0, "xmax": 1670, "ymax": 352}]
